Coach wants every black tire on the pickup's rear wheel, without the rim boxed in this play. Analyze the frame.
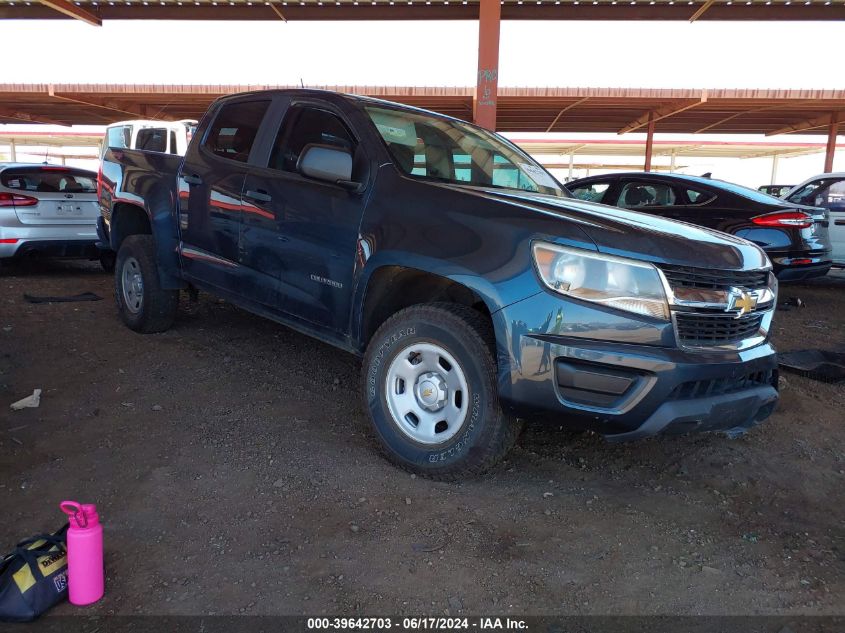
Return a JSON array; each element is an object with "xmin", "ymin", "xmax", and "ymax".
[{"xmin": 114, "ymin": 235, "xmax": 179, "ymax": 334}]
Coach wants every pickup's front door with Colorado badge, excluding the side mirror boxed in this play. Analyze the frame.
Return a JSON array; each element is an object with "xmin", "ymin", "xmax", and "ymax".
[{"xmin": 240, "ymin": 101, "xmax": 367, "ymax": 333}]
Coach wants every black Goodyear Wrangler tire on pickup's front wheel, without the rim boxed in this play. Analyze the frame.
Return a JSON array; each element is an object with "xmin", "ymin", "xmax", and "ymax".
[{"xmin": 361, "ymin": 303, "xmax": 522, "ymax": 480}]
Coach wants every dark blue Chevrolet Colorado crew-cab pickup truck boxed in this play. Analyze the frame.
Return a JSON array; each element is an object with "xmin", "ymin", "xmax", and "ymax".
[{"xmin": 98, "ymin": 90, "xmax": 778, "ymax": 479}]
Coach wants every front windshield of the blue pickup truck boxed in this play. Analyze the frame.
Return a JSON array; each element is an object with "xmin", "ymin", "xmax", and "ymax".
[{"xmin": 364, "ymin": 107, "xmax": 569, "ymax": 197}]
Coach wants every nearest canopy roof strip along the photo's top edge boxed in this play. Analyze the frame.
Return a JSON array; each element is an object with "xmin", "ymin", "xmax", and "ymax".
[{"xmin": 6, "ymin": 0, "xmax": 845, "ymax": 24}]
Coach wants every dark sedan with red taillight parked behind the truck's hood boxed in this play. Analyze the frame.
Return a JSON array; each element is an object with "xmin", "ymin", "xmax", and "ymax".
[{"xmin": 566, "ymin": 172, "xmax": 832, "ymax": 281}]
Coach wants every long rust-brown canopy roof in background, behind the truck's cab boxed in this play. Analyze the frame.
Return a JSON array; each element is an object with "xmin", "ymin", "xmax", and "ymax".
[{"xmin": 0, "ymin": 84, "xmax": 845, "ymax": 134}]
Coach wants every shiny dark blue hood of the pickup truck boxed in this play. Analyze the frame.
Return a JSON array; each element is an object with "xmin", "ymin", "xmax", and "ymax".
[{"xmin": 445, "ymin": 185, "xmax": 770, "ymax": 270}]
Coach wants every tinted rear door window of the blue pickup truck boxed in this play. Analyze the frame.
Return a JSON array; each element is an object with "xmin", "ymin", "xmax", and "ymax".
[{"xmin": 203, "ymin": 100, "xmax": 270, "ymax": 163}]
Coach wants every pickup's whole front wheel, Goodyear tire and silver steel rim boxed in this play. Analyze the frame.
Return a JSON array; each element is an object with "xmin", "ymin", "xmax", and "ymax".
[{"xmin": 363, "ymin": 303, "xmax": 521, "ymax": 480}]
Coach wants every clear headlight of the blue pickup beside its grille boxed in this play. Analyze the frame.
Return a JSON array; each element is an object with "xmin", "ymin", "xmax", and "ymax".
[{"xmin": 534, "ymin": 242, "xmax": 669, "ymax": 321}]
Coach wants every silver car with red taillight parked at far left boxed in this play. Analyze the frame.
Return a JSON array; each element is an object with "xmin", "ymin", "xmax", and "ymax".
[{"xmin": 0, "ymin": 163, "xmax": 111, "ymax": 269}]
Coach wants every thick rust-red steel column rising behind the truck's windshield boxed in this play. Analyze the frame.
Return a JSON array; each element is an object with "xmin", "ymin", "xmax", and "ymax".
[{"xmin": 474, "ymin": 0, "xmax": 502, "ymax": 131}]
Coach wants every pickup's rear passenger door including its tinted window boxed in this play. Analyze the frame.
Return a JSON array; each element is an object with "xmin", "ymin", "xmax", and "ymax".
[{"xmin": 178, "ymin": 95, "xmax": 272, "ymax": 292}]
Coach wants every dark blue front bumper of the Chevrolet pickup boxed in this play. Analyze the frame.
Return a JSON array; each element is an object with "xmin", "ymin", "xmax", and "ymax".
[{"xmin": 493, "ymin": 293, "xmax": 778, "ymax": 441}]
